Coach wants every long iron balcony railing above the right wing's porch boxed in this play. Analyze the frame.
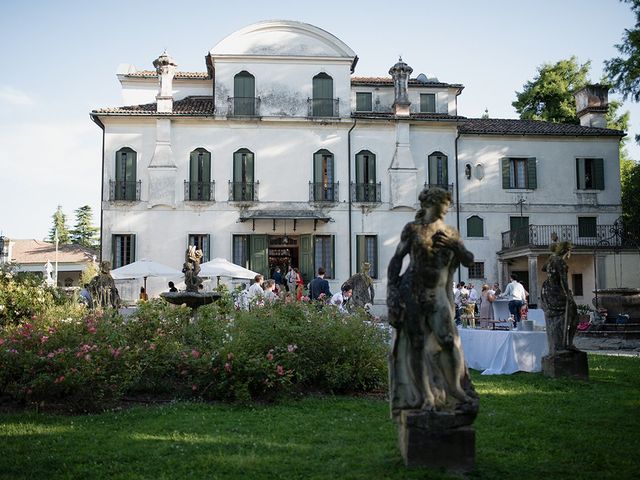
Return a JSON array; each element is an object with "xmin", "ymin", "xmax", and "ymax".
[{"xmin": 502, "ymin": 225, "xmax": 633, "ymax": 250}]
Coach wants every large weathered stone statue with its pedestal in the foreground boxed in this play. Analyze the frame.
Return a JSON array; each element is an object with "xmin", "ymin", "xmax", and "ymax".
[{"xmin": 387, "ymin": 187, "xmax": 479, "ymax": 470}]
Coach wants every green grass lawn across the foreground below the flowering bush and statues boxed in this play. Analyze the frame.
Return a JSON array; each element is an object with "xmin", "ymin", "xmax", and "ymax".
[{"xmin": 0, "ymin": 355, "xmax": 640, "ymax": 480}]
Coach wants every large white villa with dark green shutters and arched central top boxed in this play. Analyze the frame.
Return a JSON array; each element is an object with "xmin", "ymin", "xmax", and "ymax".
[{"xmin": 91, "ymin": 21, "xmax": 637, "ymax": 306}]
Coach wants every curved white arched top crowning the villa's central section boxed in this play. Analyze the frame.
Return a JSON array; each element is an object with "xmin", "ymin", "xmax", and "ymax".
[{"xmin": 209, "ymin": 20, "xmax": 356, "ymax": 59}]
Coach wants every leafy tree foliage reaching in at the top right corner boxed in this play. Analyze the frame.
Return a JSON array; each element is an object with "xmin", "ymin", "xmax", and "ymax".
[{"xmin": 604, "ymin": 0, "xmax": 640, "ymax": 102}]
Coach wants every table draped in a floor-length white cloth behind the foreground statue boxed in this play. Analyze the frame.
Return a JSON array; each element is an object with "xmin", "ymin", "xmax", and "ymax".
[{"xmin": 458, "ymin": 328, "xmax": 549, "ymax": 375}]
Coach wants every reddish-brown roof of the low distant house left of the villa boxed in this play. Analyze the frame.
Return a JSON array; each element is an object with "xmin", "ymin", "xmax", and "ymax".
[{"xmin": 9, "ymin": 239, "xmax": 98, "ymax": 265}]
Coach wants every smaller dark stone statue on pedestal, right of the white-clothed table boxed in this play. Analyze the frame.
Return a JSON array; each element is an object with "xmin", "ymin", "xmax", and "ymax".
[{"xmin": 540, "ymin": 242, "xmax": 589, "ymax": 380}]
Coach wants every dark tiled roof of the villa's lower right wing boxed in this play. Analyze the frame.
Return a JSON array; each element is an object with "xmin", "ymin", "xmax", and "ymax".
[{"xmin": 458, "ymin": 118, "xmax": 625, "ymax": 137}]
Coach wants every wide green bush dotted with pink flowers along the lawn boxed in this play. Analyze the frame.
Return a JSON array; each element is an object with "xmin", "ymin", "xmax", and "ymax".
[{"xmin": 0, "ymin": 298, "xmax": 387, "ymax": 409}]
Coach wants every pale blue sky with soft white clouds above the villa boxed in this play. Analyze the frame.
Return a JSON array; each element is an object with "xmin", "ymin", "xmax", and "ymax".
[{"xmin": 0, "ymin": 0, "xmax": 640, "ymax": 240}]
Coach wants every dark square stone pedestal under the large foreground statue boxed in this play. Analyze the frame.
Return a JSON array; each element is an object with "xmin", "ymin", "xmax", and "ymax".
[{"xmin": 399, "ymin": 410, "xmax": 476, "ymax": 472}]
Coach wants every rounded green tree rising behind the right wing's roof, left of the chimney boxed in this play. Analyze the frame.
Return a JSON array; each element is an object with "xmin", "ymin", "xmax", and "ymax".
[{"xmin": 511, "ymin": 57, "xmax": 591, "ymax": 124}]
